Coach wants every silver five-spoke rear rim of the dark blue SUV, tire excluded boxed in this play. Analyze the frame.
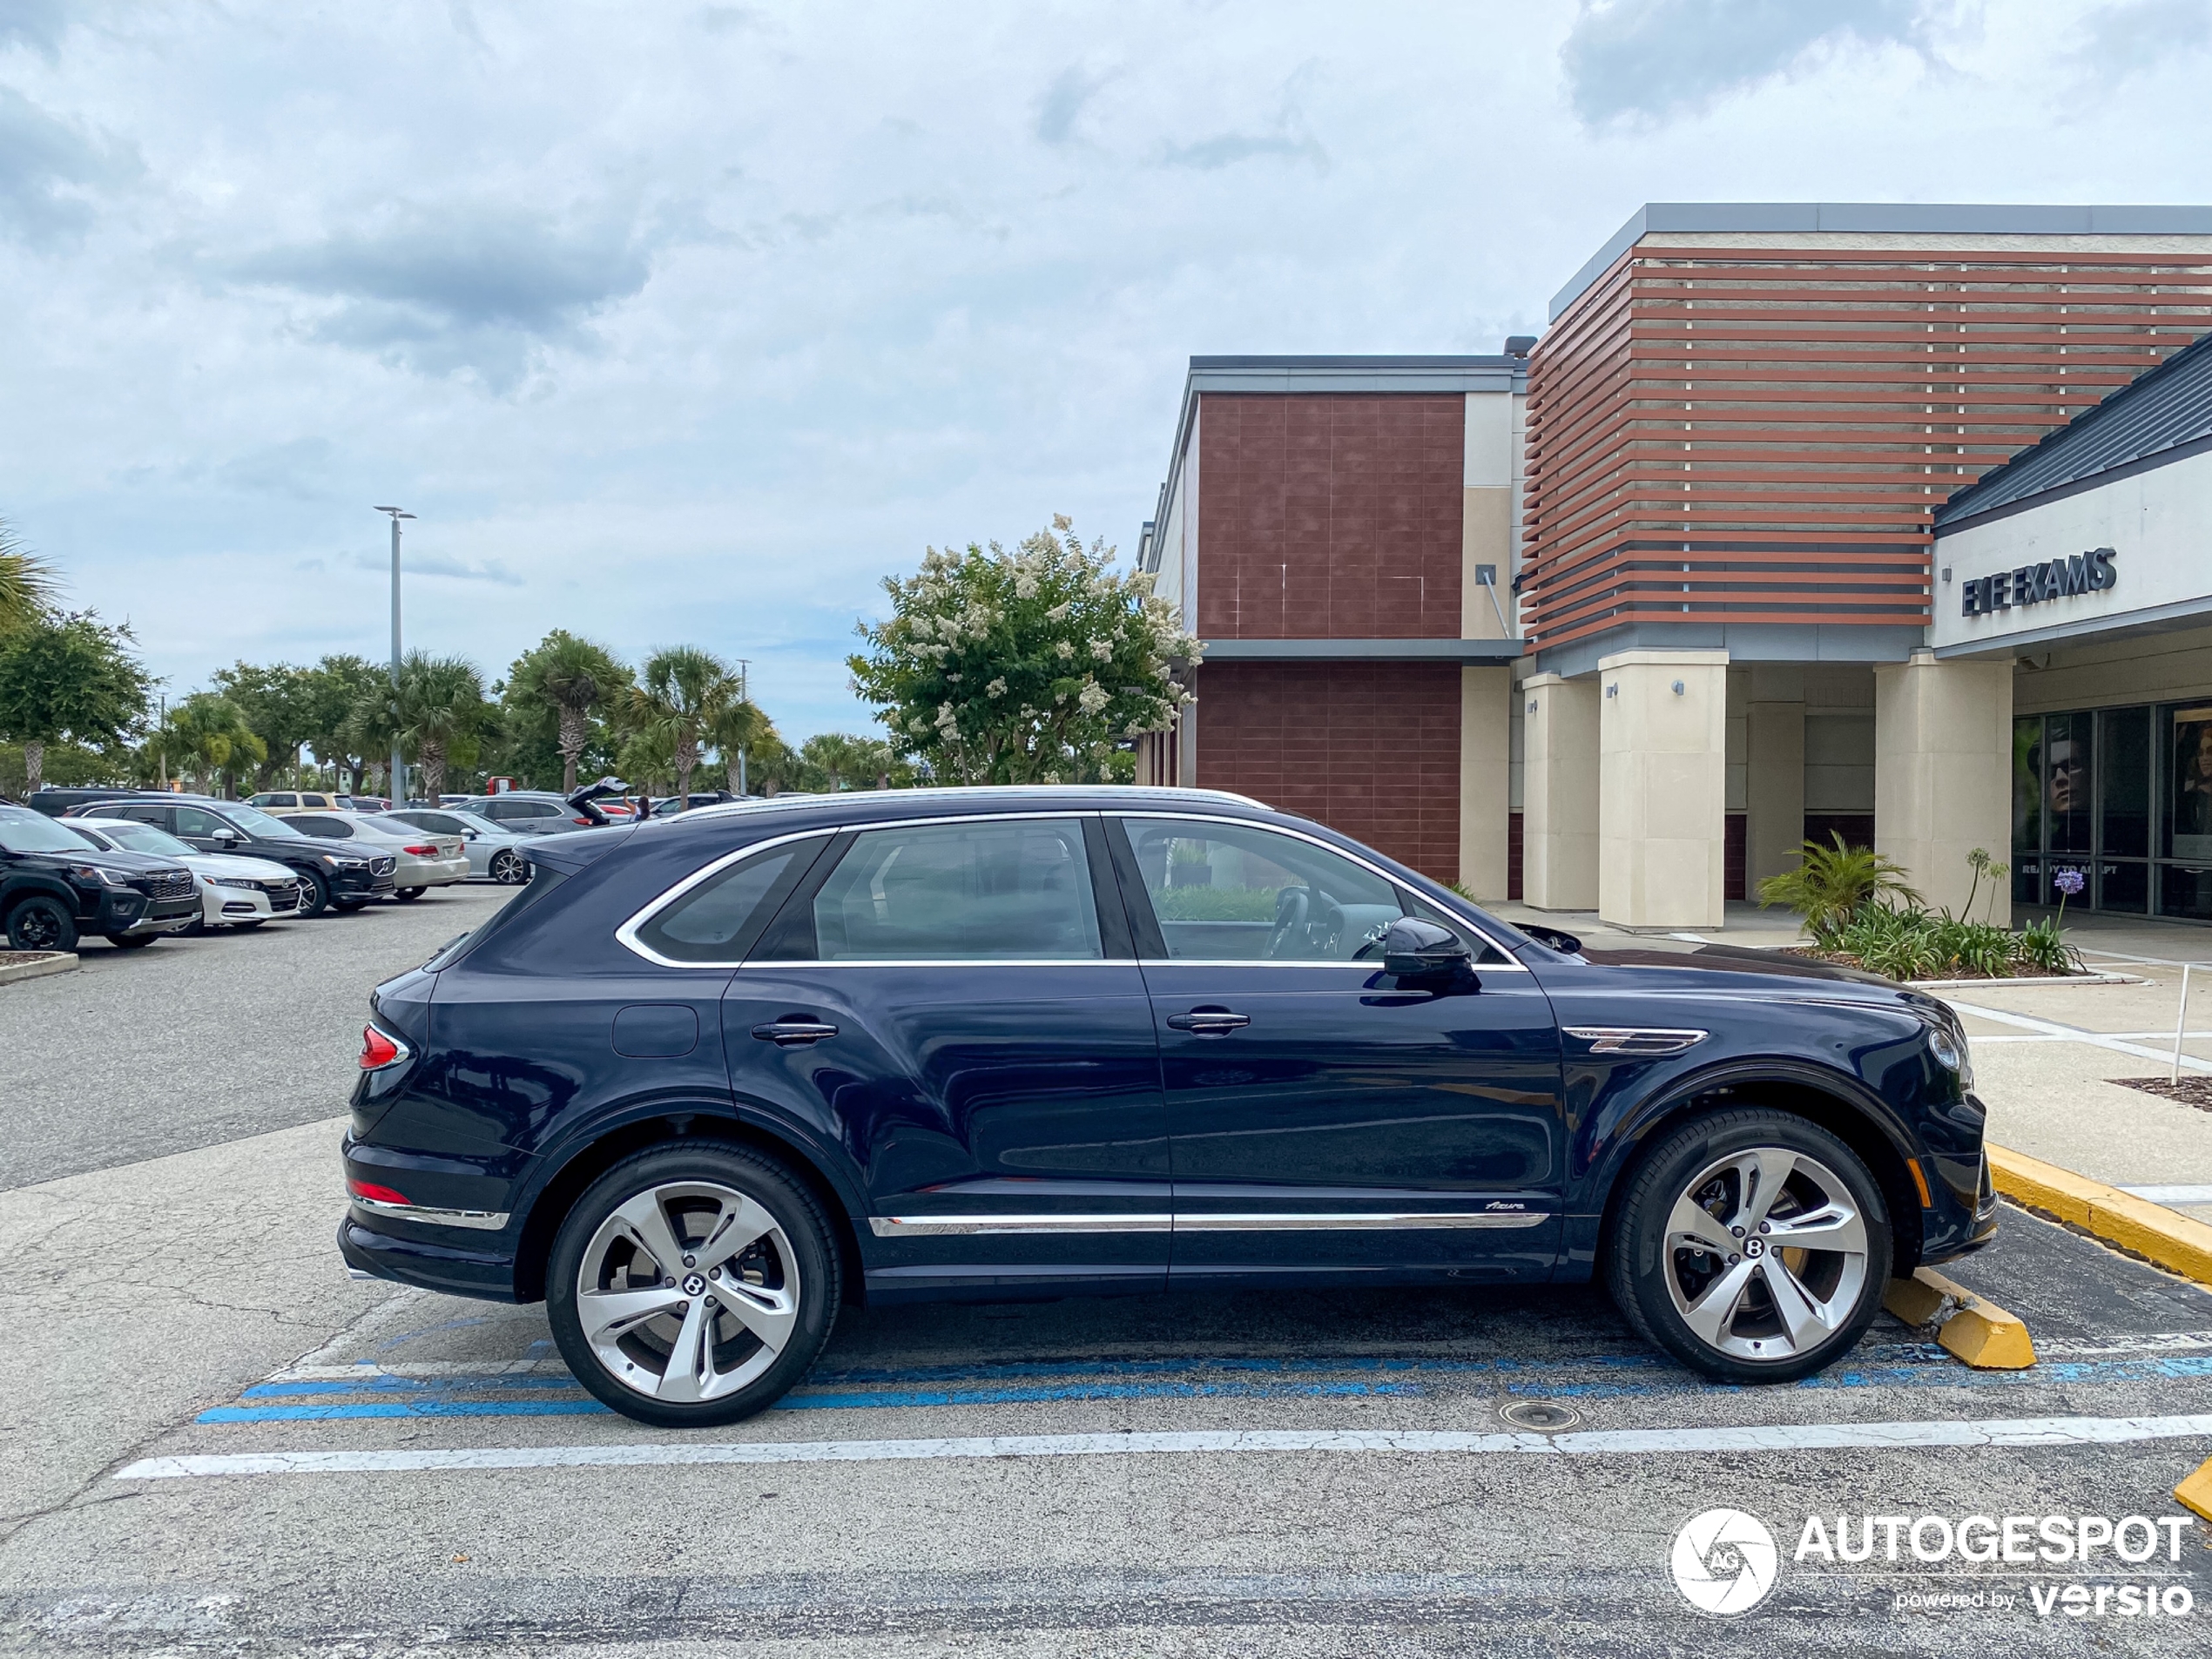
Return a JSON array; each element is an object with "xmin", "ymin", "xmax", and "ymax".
[{"xmin": 575, "ymin": 1181, "xmax": 800, "ymax": 1405}]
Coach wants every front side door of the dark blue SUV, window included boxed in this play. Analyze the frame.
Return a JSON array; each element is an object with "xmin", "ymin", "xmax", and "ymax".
[{"xmin": 1117, "ymin": 819, "xmax": 1561, "ymax": 1278}]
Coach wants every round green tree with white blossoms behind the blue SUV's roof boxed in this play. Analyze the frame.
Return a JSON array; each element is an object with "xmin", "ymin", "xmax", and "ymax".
[{"xmin": 847, "ymin": 516, "xmax": 1199, "ymax": 783}]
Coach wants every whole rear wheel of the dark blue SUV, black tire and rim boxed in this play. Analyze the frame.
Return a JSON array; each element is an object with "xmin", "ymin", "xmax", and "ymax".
[{"xmin": 546, "ymin": 1142, "xmax": 840, "ymax": 1429}]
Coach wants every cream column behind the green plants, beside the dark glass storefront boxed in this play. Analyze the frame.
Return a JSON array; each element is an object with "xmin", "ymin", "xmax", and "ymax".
[{"xmin": 1873, "ymin": 651, "xmax": 2013, "ymax": 925}]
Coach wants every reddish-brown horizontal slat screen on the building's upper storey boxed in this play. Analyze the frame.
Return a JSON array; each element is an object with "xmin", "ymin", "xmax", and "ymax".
[{"xmin": 1522, "ymin": 243, "xmax": 2212, "ymax": 646}]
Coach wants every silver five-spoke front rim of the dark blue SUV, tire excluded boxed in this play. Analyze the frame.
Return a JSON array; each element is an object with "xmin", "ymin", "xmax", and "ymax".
[{"xmin": 1662, "ymin": 1146, "xmax": 1867, "ymax": 1363}]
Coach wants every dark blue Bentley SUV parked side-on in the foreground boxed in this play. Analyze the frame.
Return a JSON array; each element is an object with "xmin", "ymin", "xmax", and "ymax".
[{"xmin": 339, "ymin": 790, "xmax": 1995, "ymax": 1426}]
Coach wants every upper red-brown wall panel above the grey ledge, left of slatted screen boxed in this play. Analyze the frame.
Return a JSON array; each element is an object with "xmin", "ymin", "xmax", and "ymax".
[{"xmin": 1197, "ymin": 394, "xmax": 1467, "ymax": 639}]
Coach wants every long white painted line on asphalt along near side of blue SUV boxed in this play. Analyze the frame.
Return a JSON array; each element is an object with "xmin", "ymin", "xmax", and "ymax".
[{"xmin": 115, "ymin": 1416, "xmax": 2212, "ymax": 1480}]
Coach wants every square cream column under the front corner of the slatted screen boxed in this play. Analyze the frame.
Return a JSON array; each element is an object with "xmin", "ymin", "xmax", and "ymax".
[{"xmin": 1597, "ymin": 651, "xmax": 1728, "ymax": 929}]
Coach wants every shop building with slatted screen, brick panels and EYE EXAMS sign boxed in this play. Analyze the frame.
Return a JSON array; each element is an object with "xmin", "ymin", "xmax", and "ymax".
[{"xmin": 1139, "ymin": 204, "xmax": 2212, "ymax": 929}]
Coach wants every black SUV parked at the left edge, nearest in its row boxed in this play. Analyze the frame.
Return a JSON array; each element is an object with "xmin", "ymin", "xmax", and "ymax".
[{"xmin": 0, "ymin": 806, "xmax": 199, "ymax": 951}]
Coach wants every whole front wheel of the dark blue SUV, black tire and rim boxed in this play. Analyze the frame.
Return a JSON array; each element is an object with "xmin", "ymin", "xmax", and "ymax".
[{"xmin": 1606, "ymin": 1109, "xmax": 1892, "ymax": 1383}]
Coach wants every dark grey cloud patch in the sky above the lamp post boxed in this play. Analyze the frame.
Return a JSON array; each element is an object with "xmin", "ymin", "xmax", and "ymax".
[{"xmin": 237, "ymin": 206, "xmax": 652, "ymax": 388}]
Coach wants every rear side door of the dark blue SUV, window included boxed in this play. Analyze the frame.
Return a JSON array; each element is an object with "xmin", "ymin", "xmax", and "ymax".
[{"xmin": 724, "ymin": 816, "xmax": 1170, "ymax": 1296}]
